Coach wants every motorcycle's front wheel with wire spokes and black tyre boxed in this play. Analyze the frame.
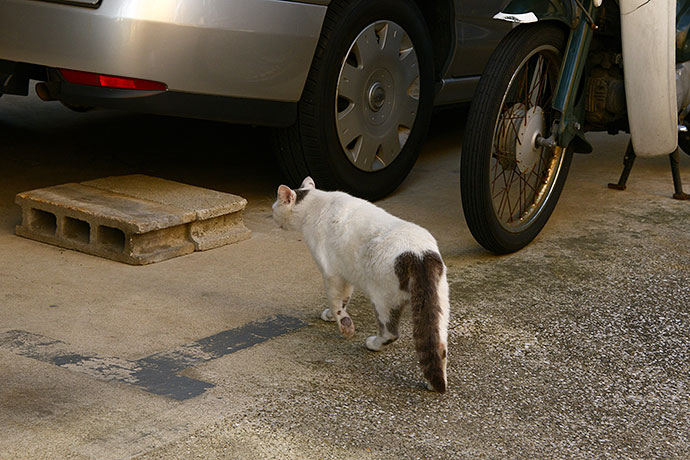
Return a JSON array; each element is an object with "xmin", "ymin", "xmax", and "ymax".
[{"xmin": 460, "ymin": 24, "xmax": 572, "ymax": 254}]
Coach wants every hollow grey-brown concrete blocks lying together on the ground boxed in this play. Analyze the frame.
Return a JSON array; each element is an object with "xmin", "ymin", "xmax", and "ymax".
[{"xmin": 16, "ymin": 175, "xmax": 251, "ymax": 265}]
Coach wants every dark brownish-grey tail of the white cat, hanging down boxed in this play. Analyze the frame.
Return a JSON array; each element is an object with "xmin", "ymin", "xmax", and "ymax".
[{"xmin": 396, "ymin": 251, "xmax": 450, "ymax": 393}]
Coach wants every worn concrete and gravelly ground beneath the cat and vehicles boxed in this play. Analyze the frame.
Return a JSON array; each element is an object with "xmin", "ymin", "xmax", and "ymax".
[{"xmin": 0, "ymin": 92, "xmax": 690, "ymax": 460}]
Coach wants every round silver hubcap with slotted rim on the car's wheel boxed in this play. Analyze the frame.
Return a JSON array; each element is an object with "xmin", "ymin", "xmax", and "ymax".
[{"xmin": 335, "ymin": 21, "xmax": 419, "ymax": 172}]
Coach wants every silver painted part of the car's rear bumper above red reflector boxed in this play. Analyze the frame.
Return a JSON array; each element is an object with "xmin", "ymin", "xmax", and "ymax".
[{"xmin": 0, "ymin": 0, "xmax": 326, "ymax": 102}]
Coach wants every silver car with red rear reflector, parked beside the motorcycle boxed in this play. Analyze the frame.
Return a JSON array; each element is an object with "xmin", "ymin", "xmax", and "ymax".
[{"xmin": 0, "ymin": 0, "xmax": 509, "ymax": 199}]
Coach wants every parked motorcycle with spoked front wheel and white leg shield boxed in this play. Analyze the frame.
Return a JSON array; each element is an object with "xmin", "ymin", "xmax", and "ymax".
[{"xmin": 460, "ymin": 0, "xmax": 690, "ymax": 254}]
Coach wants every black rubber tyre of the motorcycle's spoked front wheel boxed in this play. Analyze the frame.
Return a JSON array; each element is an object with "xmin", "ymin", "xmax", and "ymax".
[{"xmin": 460, "ymin": 23, "xmax": 572, "ymax": 254}]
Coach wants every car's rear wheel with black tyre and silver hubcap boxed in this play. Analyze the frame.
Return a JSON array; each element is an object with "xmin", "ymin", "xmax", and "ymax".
[{"xmin": 275, "ymin": 0, "xmax": 434, "ymax": 200}]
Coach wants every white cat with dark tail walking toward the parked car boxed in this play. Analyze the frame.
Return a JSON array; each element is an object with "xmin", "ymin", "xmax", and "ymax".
[{"xmin": 273, "ymin": 177, "xmax": 450, "ymax": 393}]
